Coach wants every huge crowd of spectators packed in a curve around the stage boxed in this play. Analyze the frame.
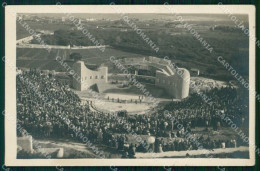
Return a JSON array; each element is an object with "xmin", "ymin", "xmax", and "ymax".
[{"xmin": 17, "ymin": 69, "xmax": 248, "ymax": 158}]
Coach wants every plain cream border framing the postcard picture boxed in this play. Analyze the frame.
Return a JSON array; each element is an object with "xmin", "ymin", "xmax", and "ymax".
[{"xmin": 5, "ymin": 4, "xmax": 255, "ymax": 166}]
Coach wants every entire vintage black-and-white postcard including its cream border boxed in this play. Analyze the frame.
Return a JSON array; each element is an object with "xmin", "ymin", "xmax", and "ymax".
[{"xmin": 2, "ymin": 2, "xmax": 260, "ymax": 166}]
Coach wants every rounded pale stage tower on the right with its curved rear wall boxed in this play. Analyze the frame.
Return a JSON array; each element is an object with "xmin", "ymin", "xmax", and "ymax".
[{"xmin": 123, "ymin": 56, "xmax": 190, "ymax": 99}]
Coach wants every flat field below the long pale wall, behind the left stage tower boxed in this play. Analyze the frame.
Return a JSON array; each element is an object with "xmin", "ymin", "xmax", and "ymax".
[{"xmin": 17, "ymin": 48, "xmax": 147, "ymax": 71}]
